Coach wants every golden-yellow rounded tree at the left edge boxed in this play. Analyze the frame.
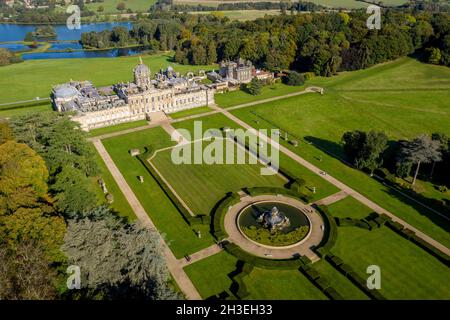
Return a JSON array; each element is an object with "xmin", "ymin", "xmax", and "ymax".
[{"xmin": 0, "ymin": 141, "xmax": 48, "ymax": 214}]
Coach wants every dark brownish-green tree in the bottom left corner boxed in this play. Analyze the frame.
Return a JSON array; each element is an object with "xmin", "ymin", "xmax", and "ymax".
[{"xmin": 0, "ymin": 242, "xmax": 58, "ymax": 300}]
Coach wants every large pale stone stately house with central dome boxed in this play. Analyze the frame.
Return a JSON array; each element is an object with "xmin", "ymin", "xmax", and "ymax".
[{"xmin": 51, "ymin": 59, "xmax": 215, "ymax": 130}]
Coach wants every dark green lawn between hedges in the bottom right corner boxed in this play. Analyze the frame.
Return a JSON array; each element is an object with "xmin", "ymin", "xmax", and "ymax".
[{"xmin": 332, "ymin": 227, "xmax": 450, "ymax": 299}]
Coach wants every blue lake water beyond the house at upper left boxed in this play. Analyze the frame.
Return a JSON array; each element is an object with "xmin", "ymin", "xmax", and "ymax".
[{"xmin": 0, "ymin": 22, "xmax": 138, "ymax": 60}]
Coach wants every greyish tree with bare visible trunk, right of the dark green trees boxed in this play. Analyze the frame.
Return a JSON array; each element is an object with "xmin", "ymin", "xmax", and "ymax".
[{"xmin": 400, "ymin": 134, "xmax": 442, "ymax": 186}]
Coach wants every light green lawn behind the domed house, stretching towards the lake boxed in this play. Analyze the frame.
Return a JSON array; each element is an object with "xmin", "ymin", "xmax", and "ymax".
[{"xmin": 0, "ymin": 53, "xmax": 215, "ymax": 103}]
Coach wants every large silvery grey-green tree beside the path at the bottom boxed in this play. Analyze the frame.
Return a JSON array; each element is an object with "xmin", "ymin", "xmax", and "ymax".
[{"xmin": 63, "ymin": 208, "xmax": 179, "ymax": 299}]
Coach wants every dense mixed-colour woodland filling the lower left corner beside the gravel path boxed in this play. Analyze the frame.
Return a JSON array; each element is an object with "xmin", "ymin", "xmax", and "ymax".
[{"xmin": 0, "ymin": 116, "xmax": 179, "ymax": 300}]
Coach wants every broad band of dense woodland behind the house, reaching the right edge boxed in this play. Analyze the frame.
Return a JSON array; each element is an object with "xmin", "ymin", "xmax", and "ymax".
[{"xmin": 81, "ymin": 10, "xmax": 450, "ymax": 76}]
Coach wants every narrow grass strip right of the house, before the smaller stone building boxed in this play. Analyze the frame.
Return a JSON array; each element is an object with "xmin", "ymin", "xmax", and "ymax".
[{"xmin": 214, "ymin": 83, "xmax": 305, "ymax": 108}]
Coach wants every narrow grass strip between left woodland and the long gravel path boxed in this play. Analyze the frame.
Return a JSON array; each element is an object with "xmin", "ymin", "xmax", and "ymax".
[{"xmin": 90, "ymin": 149, "xmax": 136, "ymax": 221}]
